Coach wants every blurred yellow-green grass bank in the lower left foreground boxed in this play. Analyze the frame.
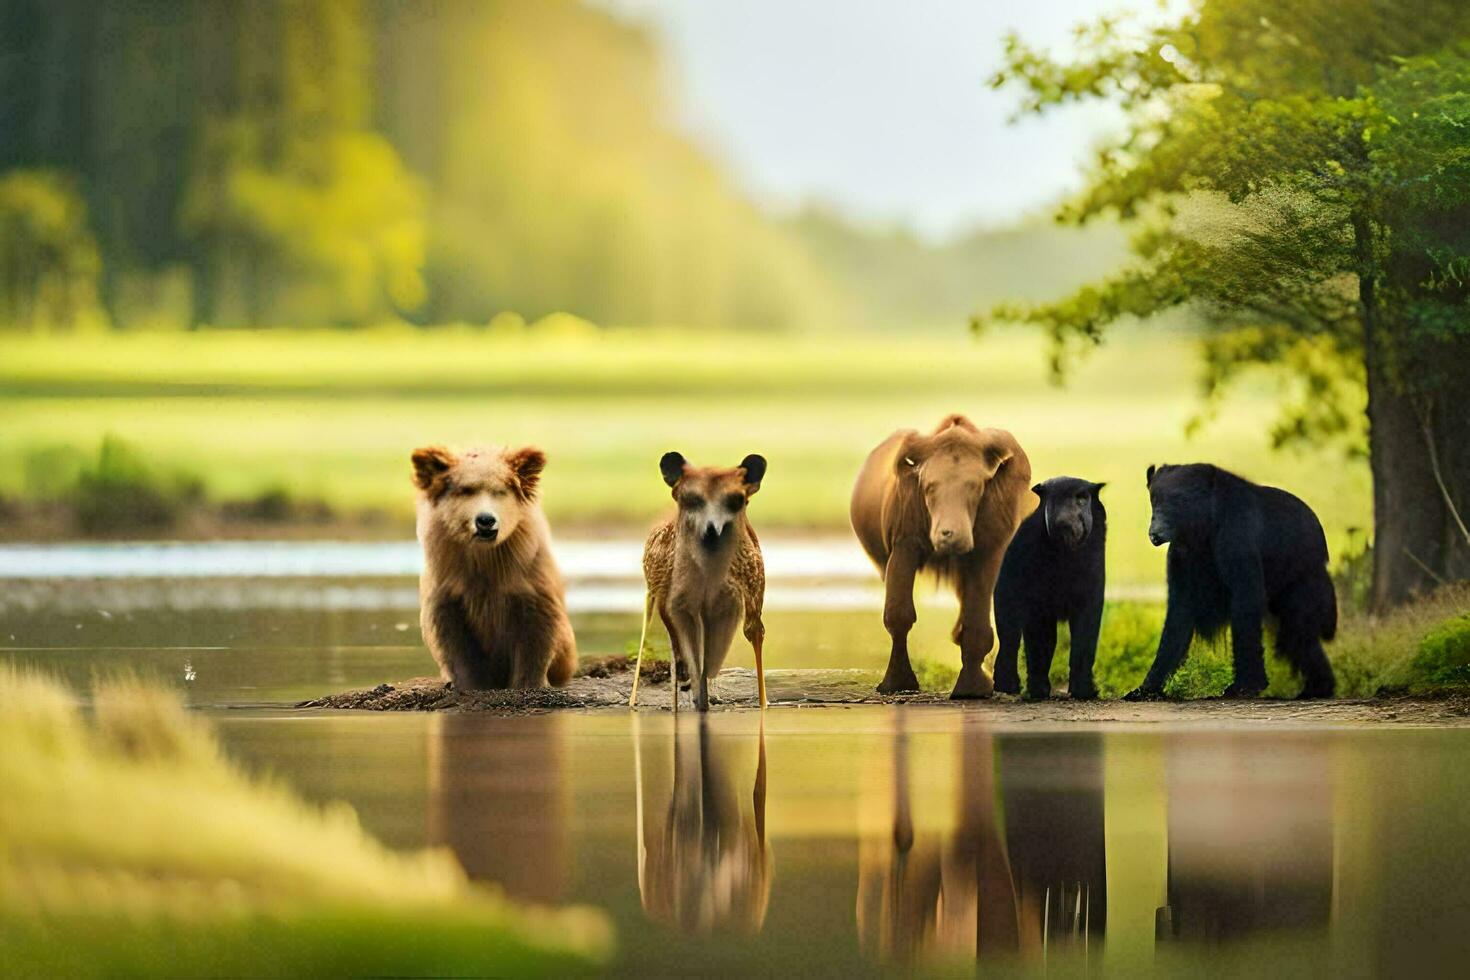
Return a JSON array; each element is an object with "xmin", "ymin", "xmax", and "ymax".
[{"xmin": 0, "ymin": 666, "xmax": 612, "ymax": 976}]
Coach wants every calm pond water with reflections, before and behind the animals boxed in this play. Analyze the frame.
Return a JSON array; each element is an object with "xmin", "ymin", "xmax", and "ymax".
[{"xmin": 0, "ymin": 548, "xmax": 1470, "ymax": 976}]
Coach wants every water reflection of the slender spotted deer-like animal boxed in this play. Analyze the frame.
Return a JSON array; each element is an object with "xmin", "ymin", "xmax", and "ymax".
[{"xmin": 634, "ymin": 716, "xmax": 772, "ymax": 936}]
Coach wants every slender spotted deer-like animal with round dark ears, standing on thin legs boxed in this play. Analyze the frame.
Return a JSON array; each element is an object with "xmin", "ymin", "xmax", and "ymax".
[{"xmin": 628, "ymin": 453, "xmax": 766, "ymax": 711}]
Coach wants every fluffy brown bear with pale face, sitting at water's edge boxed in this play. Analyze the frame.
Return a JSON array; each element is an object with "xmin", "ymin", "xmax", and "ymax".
[{"xmin": 413, "ymin": 447, "xmax": 576, "ymax": 691}]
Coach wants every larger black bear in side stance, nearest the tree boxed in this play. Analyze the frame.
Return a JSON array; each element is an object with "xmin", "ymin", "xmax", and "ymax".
[{"xmin": 1125, "ymin": 463, "xmax": 1338, "ymax": 701}]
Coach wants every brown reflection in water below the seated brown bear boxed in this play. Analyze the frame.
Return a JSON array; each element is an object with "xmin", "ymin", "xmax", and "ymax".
[{"xmin": 428, "ymin": 711, "xmax": 570, "ymax": 902}]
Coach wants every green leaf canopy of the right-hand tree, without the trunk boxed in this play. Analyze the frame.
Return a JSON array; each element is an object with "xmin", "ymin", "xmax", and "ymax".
[{"xmin": 980, "ymin": 0, "xmax": 1470, "ymax": 414}]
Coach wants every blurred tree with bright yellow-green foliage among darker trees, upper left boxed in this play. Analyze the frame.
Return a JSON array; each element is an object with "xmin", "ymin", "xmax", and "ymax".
[{"xmin": 181, "ymin": 0, "xmax": 428, "ymax": 325}]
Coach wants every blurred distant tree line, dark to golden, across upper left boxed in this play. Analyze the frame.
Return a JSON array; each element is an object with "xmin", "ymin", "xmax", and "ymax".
[{"xmin": 0, "ymin": 0, "xmax": 836, "ymax": 328}]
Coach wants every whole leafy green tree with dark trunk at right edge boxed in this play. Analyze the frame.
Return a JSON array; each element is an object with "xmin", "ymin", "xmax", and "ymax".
[{"xmin": 978, "ymin": 0, "xmax": 1470, "ymax": 608}]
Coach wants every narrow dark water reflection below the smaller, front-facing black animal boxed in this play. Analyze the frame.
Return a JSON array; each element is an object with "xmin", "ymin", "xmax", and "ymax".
[{"xmin": 1000, "ymin": 733, "xmax": 1107, "ymax": 949}]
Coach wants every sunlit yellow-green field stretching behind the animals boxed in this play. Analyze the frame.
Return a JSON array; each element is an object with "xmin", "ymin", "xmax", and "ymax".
[{"xmin": 0, "ymin": 323, "xmax": 1370, "ymax": 583}]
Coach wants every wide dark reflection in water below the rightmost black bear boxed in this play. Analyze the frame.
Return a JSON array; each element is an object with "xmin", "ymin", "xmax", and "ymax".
[{"xmin": 1158, "ymin": 739, "xmax": 1333, "ymax": 942}]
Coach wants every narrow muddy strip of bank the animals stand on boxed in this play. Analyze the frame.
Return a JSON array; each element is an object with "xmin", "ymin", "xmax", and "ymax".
[{"xmin": 297, "ymin": 657, "xmax": 1470, "ymax": 727}]
